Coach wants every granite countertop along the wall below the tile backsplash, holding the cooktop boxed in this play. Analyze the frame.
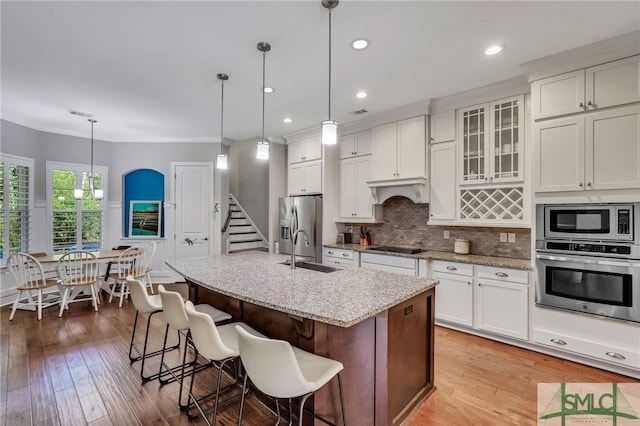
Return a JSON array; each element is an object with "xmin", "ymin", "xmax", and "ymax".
[{"xmin": 324, "ymin": 244, "xmax": 531, "ymax": 270}]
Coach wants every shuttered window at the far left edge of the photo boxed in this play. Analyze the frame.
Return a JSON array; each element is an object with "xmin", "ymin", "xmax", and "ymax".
[{"xmin": 0, "ymin": 154, "xmax": 33, "ymax": 265}]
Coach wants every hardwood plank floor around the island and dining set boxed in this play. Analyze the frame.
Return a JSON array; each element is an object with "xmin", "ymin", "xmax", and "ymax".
[{"xmin": 0, "ymin": 285, "xmax": 638, "ymax": 426}]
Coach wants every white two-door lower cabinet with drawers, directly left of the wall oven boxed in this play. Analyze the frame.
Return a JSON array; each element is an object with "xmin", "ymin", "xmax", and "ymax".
[{"xmin": 431, "ymin": 260, "xmax": 529, "ymax": 340}]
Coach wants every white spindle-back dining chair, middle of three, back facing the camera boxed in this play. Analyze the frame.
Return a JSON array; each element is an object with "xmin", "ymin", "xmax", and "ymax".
[{"xmin": 58, "ymin": 250, "xmax": 100, "ymax": 317}]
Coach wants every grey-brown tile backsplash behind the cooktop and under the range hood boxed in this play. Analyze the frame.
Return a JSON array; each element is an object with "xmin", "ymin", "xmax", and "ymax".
[{"xmin": 353, "ymin": 197, "xmax": 531, "ymax": 259}]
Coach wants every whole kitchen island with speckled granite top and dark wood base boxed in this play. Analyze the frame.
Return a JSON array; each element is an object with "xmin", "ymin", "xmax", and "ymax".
[{"xmin": 167, "ymin": 252, "xmax": 435, "ymax": 426}]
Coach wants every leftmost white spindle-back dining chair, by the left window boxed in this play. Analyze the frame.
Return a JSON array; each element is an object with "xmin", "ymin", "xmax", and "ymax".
[{"xmin": 7, "ymin": 253, "xmax": 61, "ymax": 321}]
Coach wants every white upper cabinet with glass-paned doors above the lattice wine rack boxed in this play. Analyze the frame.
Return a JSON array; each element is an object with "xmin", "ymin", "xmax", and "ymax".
[{"xmin": 458, "ymin": 96, "xmax": 524, "ymax": 185}]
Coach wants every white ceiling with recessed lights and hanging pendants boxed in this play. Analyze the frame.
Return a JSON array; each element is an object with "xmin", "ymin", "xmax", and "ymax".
[{"xmin": 0, "ymin": 0, "xmax": 640, "ymax": 142}]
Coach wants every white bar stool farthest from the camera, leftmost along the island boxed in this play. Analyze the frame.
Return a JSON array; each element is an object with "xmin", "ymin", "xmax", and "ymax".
[{"xmin": 127, "ymin": 275, "xmax": 180, "ymax": 383}]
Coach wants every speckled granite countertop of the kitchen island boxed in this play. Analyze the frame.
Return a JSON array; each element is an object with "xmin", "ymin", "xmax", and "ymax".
[{"xmin": 166, "ymin": 251, "xmax": 436, "ymax": 327}]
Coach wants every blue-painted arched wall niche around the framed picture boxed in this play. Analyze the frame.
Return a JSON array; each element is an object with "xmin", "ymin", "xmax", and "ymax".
[{"xmin": 122, "ymin": 169, "xmax": 164, "ymax": 238}]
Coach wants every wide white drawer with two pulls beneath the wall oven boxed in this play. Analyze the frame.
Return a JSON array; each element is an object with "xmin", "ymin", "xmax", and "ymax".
[{"xmin": 533, "ymin": 329, "xmax": 640, "ymax": 369}]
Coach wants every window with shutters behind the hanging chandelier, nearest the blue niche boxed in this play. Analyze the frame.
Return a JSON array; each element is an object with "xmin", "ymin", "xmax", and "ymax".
[{"xmin": 47, "ymin": 162, "xmax": 106, "ymax": 252}]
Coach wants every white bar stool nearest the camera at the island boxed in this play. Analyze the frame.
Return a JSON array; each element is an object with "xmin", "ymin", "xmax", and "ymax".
[{"xmin": 236, "ymin": 327, "xmax": 346, "ymax": 426}]
